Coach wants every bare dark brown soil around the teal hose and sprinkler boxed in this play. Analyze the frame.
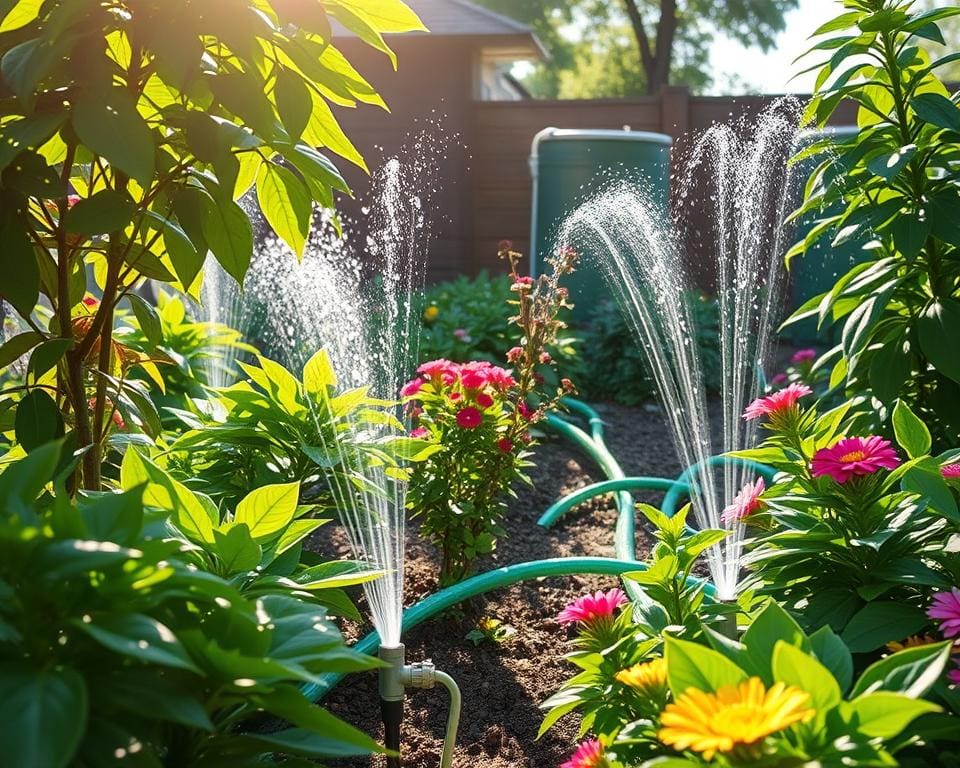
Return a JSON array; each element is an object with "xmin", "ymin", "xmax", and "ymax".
[{"xmin": 313, "ymin": 405, "xmax": 680, "ymax": 768}]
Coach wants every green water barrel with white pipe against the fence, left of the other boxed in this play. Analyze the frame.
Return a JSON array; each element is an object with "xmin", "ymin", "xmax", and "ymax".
[{"xmin": 530, "ymin": 128, "xmax": 673, "ymax": 321}]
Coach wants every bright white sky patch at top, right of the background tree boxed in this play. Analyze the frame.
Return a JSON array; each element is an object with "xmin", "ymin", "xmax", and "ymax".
[{"xmin": 710, "ymin": 0, "xmax": 843, "ymax": 93}]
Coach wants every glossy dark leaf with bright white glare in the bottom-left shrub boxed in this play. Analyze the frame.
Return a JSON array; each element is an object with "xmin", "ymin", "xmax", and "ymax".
[{"xmin": 74, "ymin": 613, "xmax": 200, "ymax": 673}]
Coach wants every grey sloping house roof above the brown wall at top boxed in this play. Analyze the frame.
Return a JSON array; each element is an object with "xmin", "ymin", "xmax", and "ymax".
[{"xmin": 333, "ymin": 0, "xmax": 545, "ymax": 58}]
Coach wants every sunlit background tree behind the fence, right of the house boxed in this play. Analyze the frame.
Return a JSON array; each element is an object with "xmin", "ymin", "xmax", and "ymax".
[{"xmin": 477, "ymin": 0, "xmax": 799, "ymax": 97}]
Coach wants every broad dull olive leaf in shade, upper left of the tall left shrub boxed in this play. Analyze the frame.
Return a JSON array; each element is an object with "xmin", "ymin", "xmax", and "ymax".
[{"xmin": 73, "ymin": 87, "xmax": 154, "ymax": 188}]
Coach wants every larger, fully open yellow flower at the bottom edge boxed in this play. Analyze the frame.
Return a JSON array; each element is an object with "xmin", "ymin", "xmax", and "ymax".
[{"xmin": 657, "ymin": 677, "xmax": 816, "ymax": 760}]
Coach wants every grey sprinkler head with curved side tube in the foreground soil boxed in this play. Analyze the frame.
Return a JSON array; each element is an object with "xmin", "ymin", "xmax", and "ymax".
[{"xmin": 379, "ymin": 643, "xmax": 460, "ymax": 768}]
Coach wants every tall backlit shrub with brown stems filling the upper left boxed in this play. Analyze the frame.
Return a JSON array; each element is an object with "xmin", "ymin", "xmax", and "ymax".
[{"xmin": 0, "ymin": 0, "xmax": 423, "ymax": 490}]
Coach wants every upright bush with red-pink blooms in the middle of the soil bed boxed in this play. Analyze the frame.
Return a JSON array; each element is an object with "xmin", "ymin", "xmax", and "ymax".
[{"xmin": 402, "ymin": 246, "xmax": 576, "ymax": 584}]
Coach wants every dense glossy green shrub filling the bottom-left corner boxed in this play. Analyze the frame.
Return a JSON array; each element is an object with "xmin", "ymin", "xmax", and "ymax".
[{"xmin": 0, "ymin": 441, "xmax": 378, "ymax": 768}]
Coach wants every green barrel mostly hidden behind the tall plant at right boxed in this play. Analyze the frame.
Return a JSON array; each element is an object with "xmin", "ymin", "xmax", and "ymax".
[{"xmin": 786, "ymin": 126, "xmax": 870, "ymax": 346}]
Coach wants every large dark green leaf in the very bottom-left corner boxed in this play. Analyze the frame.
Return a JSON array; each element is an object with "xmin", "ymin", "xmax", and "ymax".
[{"xmin": 0, "ymin": 662, "xmax": 87, "ymax": 768}]
